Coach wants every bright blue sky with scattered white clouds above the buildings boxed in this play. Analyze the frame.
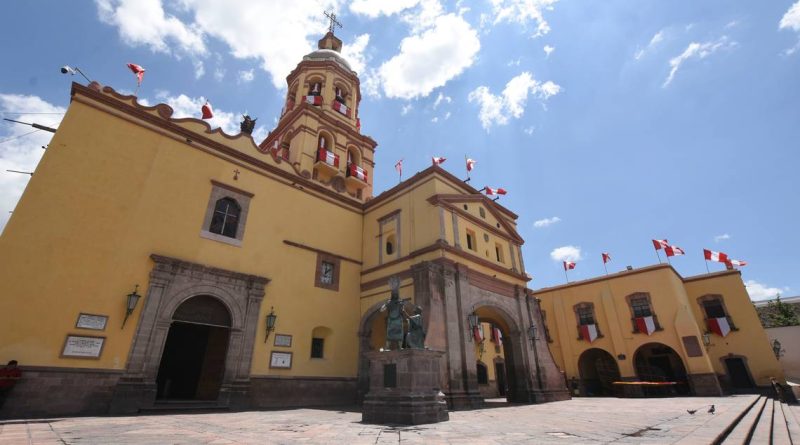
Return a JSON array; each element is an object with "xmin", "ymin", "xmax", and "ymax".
[{"xmin": 0, "ymin": 0, "xmax": 800, "ymax": 299}]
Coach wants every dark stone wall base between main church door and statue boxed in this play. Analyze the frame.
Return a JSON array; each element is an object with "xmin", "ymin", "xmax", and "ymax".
[{"xmin": 249, "ymin": 376, "xmax": 357, "ymax": 409}]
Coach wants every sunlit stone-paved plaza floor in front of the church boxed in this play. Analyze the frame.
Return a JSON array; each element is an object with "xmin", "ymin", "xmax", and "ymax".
[{"xmin": 0, "ymin": 396, "xmax": 755, "ymax": 445}]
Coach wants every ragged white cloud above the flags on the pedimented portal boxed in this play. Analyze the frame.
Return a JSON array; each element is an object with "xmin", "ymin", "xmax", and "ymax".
[{"xmin": 468, "ymin": 71, "xmax": 561, "ymax": 131}]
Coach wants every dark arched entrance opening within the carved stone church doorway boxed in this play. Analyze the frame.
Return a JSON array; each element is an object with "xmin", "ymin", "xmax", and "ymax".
[{"xmin": 156, "ymin": 295, "xmax": 231, "ymax": 400}]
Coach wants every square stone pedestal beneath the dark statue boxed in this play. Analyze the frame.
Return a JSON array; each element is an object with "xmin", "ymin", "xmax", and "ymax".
[{"xmin": 361, "ymin": 349, "xmax": 450, "ymax": 425}]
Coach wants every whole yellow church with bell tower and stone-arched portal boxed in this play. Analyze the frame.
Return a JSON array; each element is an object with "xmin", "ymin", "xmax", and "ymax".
[{"xmin": 0, "ymin": 33, "xmax": 569, "ymax": 417}]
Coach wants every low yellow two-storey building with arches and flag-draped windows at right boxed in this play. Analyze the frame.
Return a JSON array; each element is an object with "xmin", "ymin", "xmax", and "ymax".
[{"xmin": 534, "ymin": 264, "xmax": 784, "ymax": 396}]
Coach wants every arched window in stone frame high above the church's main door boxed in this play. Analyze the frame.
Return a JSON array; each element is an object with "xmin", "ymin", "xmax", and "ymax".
[{"xmin": 200, "ymin": 180, "xmax": 254, "ymax": 250}]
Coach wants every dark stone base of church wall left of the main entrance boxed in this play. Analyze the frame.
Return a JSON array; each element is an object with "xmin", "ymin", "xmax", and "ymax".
[{"xmin": 0, "ymin": 366, "xmax": 122, "ymax": 419}]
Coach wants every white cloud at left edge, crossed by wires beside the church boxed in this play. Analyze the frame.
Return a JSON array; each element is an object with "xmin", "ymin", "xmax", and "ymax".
[{"xmin": 0, "ymin": 94, "xmax": 66, "ymax": 231}]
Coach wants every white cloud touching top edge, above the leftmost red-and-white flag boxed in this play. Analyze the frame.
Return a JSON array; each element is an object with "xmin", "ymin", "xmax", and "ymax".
[{"xmin": 95, "ymin": 0, "xmax": 206, "ymax": 55}]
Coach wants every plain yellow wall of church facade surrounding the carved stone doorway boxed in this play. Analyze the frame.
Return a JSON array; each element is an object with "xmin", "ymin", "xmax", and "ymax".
[{"xmin": 0, "ymin": 92, "xmax": 362, "ymax": 376}]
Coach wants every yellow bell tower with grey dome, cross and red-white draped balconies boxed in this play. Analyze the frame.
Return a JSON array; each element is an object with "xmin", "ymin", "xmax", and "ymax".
[{"xmin": 259, "ymin": 13, "xmax": 378, "ymax": 202}]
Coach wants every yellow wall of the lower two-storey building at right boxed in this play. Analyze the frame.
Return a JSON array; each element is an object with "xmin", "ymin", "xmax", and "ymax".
[{"xmin": 534, "ymin": 265, "xmax": 782, "ymax": 385}]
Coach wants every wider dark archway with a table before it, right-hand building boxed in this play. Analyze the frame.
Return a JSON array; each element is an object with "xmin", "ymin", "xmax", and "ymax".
[{"xmin": 633, "ymin": 343, "xmax": 689, "ymax": 395}]
